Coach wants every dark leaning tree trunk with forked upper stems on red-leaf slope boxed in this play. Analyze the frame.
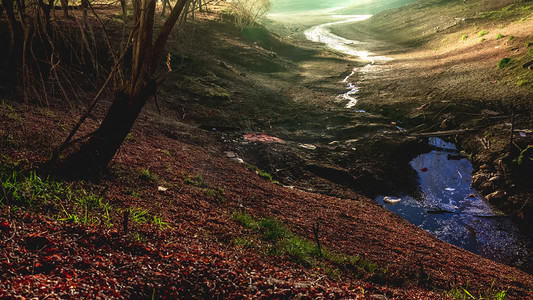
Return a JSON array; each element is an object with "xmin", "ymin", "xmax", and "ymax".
[{"xmin": 64, "ymin": 0, "xmax": 187, "ymax": 177}]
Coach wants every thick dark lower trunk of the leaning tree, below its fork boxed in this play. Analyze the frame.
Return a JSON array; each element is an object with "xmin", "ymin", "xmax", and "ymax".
[{"xmin": 70, "ymin": 81, "xmax": 156, "ymax": 177}]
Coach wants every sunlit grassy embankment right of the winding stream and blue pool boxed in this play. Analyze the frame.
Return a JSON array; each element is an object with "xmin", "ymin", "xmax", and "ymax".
[{"xmin": 330, "ymin": 1, "xmax": 533, "ymax": 232}]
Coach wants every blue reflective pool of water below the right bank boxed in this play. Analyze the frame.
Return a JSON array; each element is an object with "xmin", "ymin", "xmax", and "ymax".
[{"xmin": 376, "ymin": 138, "xmax": 533, "ymax": 267}]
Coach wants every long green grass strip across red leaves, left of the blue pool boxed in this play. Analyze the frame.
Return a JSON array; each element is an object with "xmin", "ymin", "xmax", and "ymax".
[{"xmin": 231, "ymin": 211, "xmax": 386, "ymax": 276}]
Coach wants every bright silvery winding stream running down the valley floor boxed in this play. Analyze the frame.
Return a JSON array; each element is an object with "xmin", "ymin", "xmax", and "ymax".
[{"xmin": 305, "ymin": 15, "xmax": 390, "ymax": 112}]
